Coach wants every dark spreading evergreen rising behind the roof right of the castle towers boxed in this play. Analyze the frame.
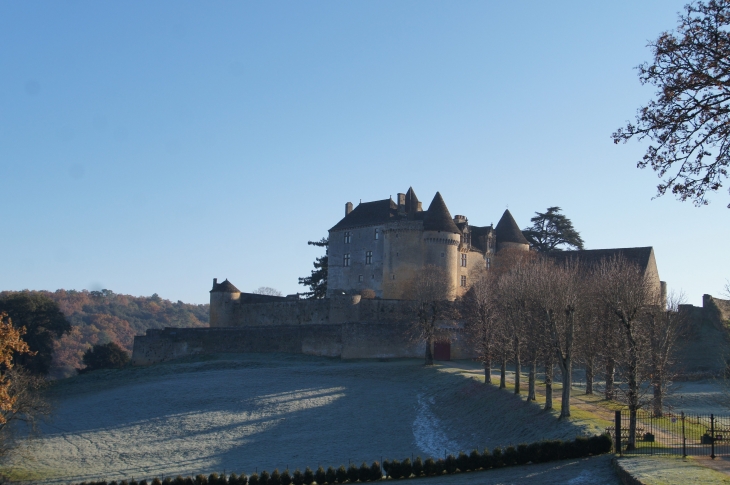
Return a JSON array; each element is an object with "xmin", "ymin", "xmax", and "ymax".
[{"xmin": 522, "ymin": 207, "xmax": 583, "ymax": 253}]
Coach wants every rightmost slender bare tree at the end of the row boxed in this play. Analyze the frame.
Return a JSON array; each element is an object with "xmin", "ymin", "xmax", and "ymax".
[{"xmin": 646, "ymin": 294, "xmax": 687, "ymax": 417}]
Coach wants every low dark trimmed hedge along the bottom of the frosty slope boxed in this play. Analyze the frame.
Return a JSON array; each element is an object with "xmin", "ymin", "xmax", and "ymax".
[{"xmin": 77, "ymin": 434, "xmax": 612, "ymax": 485}]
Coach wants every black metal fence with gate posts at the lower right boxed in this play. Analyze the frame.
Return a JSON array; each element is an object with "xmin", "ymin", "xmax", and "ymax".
[{"xmin": 606, "ymin": 411, "xmax": 730, "ymax": 458}]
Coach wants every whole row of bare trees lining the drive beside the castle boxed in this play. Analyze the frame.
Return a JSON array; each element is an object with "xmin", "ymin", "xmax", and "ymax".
[{"xmin": 411, "ymin": 252, "xmax": 684, "ymax": 443}]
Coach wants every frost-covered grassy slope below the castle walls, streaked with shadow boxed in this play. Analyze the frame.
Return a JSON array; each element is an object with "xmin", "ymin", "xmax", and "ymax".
[{"xmin": 7, "ymin": 354, "xmax": 608, "ymax": 483}]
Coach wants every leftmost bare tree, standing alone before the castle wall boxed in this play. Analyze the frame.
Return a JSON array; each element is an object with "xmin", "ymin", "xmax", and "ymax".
[{"xmin": 406, "ymin": 265, "xmax": 456, "ymax": 365}]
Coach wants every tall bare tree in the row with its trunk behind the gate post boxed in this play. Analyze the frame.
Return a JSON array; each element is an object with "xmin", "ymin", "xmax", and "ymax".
[{"xmin": 595, "ymin": 256, "xmax": 657, "ymax": 449}]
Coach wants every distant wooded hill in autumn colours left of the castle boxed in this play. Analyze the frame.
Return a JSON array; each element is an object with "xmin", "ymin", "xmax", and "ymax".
[{"xmin": 0, "ymin": 290, "xmax": 209, "ymax": 378}]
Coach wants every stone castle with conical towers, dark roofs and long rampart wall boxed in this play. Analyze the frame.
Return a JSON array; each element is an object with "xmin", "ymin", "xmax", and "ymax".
[{"xmin": 132, "ymin": 188, "xmax": 688, "ymax": 365}]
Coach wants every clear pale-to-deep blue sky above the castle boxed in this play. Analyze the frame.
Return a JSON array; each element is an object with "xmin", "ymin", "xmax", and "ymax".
[{"xmin": 0, "ymin": 0, "xmax": 730, "ymax": 304}]
